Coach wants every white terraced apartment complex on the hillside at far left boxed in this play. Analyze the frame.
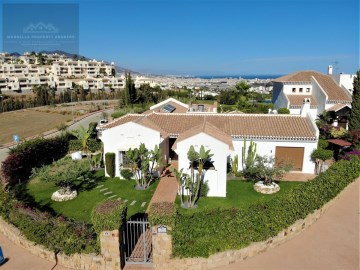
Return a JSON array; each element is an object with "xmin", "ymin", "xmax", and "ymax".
[{"xmin": 0, "ymin": 53, "xmax": 125, "ymax": 94}]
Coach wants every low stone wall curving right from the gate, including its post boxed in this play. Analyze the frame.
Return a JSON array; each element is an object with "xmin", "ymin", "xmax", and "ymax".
[{"xmin": 152, "ymin": 179, "xmax": 359, "ymax": 270}]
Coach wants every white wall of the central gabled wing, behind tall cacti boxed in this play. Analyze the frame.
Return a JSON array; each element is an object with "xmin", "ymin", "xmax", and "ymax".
[{"xmin": 176, "ymin": 133, "xmax": 230, "ymax": 197}]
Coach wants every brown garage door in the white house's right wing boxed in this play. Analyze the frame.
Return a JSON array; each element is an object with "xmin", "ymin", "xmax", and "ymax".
[{"xmin": 275, "ymin": 146, "xmax": 304, "ymax": 171}]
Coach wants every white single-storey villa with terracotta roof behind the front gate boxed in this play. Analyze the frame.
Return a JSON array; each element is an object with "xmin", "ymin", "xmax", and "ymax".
[{"xmin": 99, "ymin": 98, "xmax": 319, "ymax": 197}]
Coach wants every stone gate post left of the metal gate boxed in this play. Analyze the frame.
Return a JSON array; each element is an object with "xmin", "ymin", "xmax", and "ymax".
[{"xmin": 100, "ymin": 230, "xmax": 122, "ymax": 270}]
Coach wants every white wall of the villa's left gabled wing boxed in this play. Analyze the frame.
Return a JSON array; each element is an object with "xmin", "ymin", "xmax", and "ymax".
[{"xmin": 100, "ymin": 122, "xmax": 161, "ymax": 177}]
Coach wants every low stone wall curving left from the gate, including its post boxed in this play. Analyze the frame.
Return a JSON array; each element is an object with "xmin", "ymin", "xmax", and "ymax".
[{"xmin": 0, "ymin": 217, "xmax": 121, "ymax": 270}]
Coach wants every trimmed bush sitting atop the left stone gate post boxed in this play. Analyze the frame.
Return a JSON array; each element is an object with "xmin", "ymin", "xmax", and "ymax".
[{"xmin": 91, "ymin": 200, "xmax": 127, "ymax": 235}]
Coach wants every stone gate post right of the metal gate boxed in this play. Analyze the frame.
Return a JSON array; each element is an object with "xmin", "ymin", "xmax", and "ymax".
[{"xmin": 151, "ymin": 226, "xmax": 172, "ymax": 269}]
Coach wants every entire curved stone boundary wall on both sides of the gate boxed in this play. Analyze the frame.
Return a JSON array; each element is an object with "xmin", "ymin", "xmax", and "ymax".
[{"xmin": 0, "ymin": 179, "xmax": 359, "ymax": 270}]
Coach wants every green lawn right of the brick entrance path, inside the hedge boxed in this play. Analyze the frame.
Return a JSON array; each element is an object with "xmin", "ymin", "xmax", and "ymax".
[{"xmin": 176, "ymin": 180, "xmax": 301, "ymax": 213}]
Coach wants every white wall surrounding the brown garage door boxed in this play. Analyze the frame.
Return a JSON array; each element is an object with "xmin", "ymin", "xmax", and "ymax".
[{"xmin": 232, "ymin": 139, "xmax": 317, "ymax": 173}]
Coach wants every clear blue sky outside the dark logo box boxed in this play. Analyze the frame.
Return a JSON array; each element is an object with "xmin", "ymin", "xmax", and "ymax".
[{"xmin": 3, "ymin": 0, "xmax": 359, "ymax": 75}]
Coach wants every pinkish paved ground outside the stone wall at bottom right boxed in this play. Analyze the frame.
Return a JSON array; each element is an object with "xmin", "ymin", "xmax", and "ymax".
[{"xmin": 216, "ymin": 178, "xmax": 360, "ymax": 270}]
